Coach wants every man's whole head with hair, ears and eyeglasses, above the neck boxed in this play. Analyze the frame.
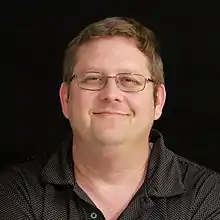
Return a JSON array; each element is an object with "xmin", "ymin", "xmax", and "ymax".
[{"xmin": 60, "ymin": 18, "xmax": 166, "ymax": 145}]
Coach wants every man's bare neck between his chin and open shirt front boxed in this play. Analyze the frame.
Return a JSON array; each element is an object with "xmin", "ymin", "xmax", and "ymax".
[{"xmin": 73, "ymin": 139, "xmax": 150, "ymax": 186}]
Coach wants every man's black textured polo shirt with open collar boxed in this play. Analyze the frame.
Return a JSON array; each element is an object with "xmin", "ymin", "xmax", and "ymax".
[{"xmin": 0, "ymin": 130, "xmax": 220, "ymax": 220}]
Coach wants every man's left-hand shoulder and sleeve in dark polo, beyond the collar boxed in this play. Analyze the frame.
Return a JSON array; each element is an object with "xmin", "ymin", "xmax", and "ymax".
[{"xmin": 0, "ymin": 156, "xmax": 49, "ymax": 219}]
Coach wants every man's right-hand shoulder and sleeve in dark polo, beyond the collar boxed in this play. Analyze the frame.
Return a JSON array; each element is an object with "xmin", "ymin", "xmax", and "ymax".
[{"xmin": 176, "ymin": 155, "xmax": 220, "ymax": 219}]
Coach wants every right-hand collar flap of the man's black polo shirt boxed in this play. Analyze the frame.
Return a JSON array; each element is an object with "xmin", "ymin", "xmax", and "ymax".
[{"xmin": 145, "ymin": 129, "xmax": 185, "ymax": 197}]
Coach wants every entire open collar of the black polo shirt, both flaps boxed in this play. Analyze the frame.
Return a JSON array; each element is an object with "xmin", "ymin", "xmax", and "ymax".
[{"xmin": 41, "ymin": 129, "xmax": 185, "ymax": 197}]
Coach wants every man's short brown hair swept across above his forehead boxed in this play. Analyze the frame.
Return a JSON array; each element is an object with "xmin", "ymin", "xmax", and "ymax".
[{"xmin": 63, "ymin": 17, "xmax": 164, "ymax": 89}]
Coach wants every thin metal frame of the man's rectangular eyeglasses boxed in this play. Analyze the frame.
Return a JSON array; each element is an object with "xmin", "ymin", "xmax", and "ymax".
[{"xmin": 69, "ymin": 72, "xmax": 159, "ymax": 92}]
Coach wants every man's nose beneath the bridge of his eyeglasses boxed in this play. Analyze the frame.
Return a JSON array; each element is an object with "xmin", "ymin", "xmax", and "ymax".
[{"xmin": 99, "ymin": 78, "xmax": 123, "ymax": 102}]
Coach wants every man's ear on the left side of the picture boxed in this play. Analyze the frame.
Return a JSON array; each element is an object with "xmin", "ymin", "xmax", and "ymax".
[{"xmin": 59, "ymin": 83, "xmax": 69, "ymax": 119}]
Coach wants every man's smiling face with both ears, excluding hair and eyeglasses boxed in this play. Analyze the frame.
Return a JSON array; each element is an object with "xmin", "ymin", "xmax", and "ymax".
[{"xmin": 60, "ymin": 37, "xmax": 165, "ymax": 145}]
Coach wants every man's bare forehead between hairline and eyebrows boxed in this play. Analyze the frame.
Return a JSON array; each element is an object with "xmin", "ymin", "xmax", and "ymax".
[{"xmin": 75, "ymin": 36, "xmax": 148, "ymax": 74}]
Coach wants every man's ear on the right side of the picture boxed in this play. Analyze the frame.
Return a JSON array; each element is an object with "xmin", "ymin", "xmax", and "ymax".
[{"xmin": 154, "ymin": 84, "xmax": 166, "ymax": 120}]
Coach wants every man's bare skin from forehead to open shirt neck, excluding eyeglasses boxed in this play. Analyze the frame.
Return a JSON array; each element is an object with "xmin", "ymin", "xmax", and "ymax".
[{"xmin": 60, "ymin": 36, "xmax": 166, "ymax": 217}]
